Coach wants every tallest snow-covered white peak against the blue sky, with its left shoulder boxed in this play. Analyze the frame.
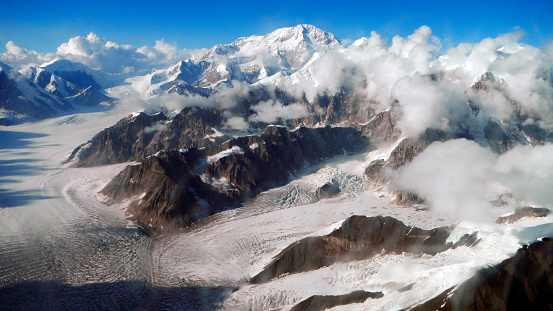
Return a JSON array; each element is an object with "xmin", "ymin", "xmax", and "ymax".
[{"xmin": 127, "ymin": 25, "xmax": 340, "ymax": 96}]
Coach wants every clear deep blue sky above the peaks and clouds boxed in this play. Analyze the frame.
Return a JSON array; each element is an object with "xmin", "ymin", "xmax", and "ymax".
[{"xmin": 0, "ymin": 0, "xmax": 553, "ymax": 52}]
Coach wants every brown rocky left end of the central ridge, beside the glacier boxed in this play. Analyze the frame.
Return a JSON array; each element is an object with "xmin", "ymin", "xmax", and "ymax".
[{"xmin": 100, "ymin": 150, "xmax": 236, "ymax": 229}]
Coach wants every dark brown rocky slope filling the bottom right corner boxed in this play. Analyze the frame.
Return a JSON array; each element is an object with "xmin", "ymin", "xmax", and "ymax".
[{"xmin": 411, "ymin": 238, "xmax": 553, "ymax": 311}]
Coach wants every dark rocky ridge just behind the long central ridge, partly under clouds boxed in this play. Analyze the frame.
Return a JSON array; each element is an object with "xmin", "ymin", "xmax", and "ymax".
[{"xmin": 68, "ymin": 87, "xmax": 386, "ymax": 166}]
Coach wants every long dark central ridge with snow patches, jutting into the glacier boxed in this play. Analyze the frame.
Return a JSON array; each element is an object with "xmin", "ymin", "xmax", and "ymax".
[{"xmin": 101, "ymin": 126, "xmax": 370, "ymax": 228}]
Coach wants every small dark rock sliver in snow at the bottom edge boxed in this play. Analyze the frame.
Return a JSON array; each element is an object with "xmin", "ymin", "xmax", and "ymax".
[{"xmin": 290, "ymin": 290, "xmax": 384, "ymax": 311}]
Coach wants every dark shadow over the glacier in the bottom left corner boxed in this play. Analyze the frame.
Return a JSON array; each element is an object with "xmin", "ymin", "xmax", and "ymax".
[{"xmin": 0, "ymin": 281, "xmax": 236, "ymax": 311}]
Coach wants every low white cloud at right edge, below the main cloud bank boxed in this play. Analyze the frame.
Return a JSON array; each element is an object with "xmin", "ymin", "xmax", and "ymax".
[{"xmin": 391, "ymin": 139, "xmax": 553, "ymax": 222}]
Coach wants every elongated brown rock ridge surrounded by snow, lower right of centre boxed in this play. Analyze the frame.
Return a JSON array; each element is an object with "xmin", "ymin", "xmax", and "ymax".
[{"xmin": 250, "ymin": 216, "xmax": 477, "ymax": 284}]
